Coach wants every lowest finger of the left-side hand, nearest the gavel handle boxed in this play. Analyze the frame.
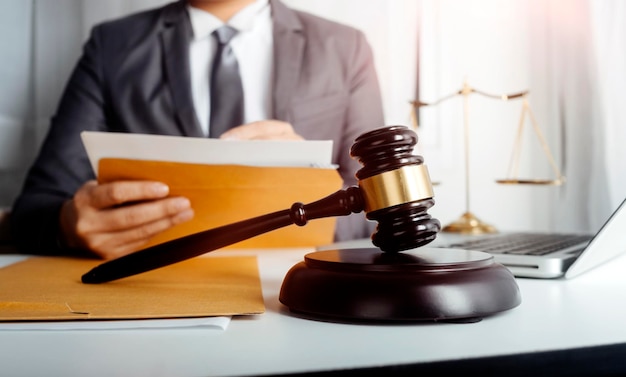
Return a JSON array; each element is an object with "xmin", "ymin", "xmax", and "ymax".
[{"xmin": 88, "ymin": 209, "xmax": 194, "ymax": 259}]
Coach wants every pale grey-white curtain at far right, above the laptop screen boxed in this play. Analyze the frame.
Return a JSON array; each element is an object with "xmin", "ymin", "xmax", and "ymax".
[{"xmin": 533, "ymin": 0, "xmax": 626, "ymax": 231}]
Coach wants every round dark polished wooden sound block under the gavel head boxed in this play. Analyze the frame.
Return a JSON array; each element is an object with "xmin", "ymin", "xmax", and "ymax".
[{"xmin": 279, "ymin": 248, "xmax": 521, "ymax": 322}]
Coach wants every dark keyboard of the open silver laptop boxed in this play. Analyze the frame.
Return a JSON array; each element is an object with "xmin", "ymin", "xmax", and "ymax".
[{"xmin": 441, "ymin": 233, "xmax": 593, "ymax": 255}]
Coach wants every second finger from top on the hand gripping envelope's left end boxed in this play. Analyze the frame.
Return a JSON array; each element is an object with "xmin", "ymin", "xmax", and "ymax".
[{"xmin": 95, "ymin": 197, "xmax": 191, "ymax": 232}]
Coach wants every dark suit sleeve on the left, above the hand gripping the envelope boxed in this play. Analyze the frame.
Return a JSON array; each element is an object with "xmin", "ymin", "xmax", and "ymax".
[{"xmin": 11, "ymin": 29, "xmax": 105, "ymax": 254}]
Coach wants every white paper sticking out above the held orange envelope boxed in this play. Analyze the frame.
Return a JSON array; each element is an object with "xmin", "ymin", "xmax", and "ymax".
[{"xmin": 81, "ymin": 131, "xmax": 333, "ymax": 172}]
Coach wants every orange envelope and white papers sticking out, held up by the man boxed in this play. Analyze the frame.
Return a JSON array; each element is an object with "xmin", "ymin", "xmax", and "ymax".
[{"xmin": 82, "ymin": 132, "xmax": 342, "ymax": 248}]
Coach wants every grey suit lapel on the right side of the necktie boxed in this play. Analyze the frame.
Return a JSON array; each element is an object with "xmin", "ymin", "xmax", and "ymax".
[{"xmin": 270, "ymin": 0, "xmax": 305, "ymax": 122}]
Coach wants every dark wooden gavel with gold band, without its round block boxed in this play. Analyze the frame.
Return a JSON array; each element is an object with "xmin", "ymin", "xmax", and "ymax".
[{"xmin": 82, "ymin": 126, "xmax": 441, "ymax": 284}]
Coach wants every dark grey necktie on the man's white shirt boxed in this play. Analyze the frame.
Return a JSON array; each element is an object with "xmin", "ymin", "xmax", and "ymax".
[{"xmin": 209, "ymin": 25, "xmax": 243, "ymax": 138}]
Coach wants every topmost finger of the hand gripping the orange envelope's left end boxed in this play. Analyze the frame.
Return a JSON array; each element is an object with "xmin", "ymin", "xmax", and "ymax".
[{"xmin": 86, "ymin": 181, "xmax": 169, "ymax": 208}]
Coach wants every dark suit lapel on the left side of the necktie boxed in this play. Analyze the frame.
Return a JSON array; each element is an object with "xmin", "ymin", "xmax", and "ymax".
[{"xmin": 161, "ymin": 1, "xmax": 203, "ymax": 137}]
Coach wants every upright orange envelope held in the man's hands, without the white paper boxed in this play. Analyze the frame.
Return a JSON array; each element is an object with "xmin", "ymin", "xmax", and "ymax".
[{"xmin": 98, "ymin": 158, "xmax": 342, "ymax": 248}]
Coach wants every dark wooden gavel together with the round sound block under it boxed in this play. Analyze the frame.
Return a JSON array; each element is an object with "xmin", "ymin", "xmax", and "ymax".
[{"xmin": 82, "ymin": 126, "xmax": 521, "ymax": 322}]
